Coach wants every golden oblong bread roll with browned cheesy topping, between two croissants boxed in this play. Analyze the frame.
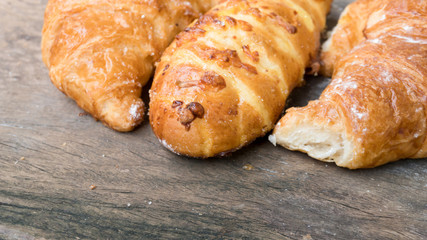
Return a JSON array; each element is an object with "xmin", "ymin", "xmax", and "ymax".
[{"xmin": 149, "ymin": 0, "xmax": 331, "ymax": 158}]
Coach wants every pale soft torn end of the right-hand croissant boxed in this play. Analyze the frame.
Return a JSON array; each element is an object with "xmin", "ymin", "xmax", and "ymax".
[{"xmin": 270, "ymin": 120, "xmax": 353, "ymax": 165}]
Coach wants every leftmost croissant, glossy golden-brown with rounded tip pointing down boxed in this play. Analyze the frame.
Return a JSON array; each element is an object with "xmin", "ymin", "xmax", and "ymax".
[{"xmin": 42, "ymin": 0, "xmax": 217, "ymax": 131}]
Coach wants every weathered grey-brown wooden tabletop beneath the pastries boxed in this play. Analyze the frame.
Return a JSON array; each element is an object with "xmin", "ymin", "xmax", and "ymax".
[{"xmin": 0, "ymin": 0, "xmax": 427, "ymax": 239}]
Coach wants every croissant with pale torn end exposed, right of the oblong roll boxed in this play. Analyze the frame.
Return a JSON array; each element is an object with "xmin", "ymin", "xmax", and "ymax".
[{"xmin": 271, "ymin": 0, "xmax": 427, "ymax": 169}]
